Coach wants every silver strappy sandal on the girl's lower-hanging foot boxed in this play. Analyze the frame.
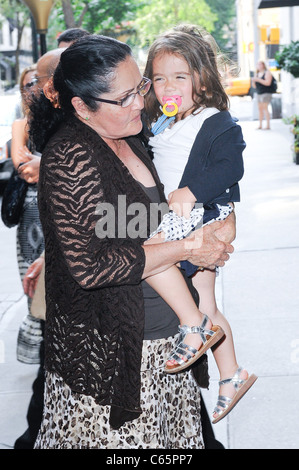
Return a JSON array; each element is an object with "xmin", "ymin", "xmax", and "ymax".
[{"xmin": 212, "ymin": 367, "xmax": 257, "ymax": 424}]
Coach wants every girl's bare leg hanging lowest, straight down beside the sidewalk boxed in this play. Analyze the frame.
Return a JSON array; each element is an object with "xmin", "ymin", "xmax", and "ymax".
[{"xmin": 192, "ymin": 270, "xmax": 248, "ymax": 418}]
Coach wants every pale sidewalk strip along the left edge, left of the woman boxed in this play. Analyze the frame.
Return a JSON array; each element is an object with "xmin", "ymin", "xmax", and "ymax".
[{"xmin": 0, "ymin": 226, "xmax": 38, "ymax": 449}]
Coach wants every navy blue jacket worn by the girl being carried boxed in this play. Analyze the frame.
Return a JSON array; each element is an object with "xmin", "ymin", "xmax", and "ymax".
[{"xmin": 179, "ymin": 111, "xmax": 246, "ymax": 205}]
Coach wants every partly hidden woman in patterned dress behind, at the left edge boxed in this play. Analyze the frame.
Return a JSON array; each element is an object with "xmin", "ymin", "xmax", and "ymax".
[{"xmin": 11, "ymin": 65, "xmax": 44, "ymax": 364}]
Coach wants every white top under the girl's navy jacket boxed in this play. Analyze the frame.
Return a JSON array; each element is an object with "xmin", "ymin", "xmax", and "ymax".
[{"xmin": 149, "ymin": 108, "xmax": 219, "ymax": 198}]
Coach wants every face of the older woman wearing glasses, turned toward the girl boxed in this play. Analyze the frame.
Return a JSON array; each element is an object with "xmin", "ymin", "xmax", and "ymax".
[{"xmin": 85, "ymin": 57, "xmax": 144, "ymax": 139}]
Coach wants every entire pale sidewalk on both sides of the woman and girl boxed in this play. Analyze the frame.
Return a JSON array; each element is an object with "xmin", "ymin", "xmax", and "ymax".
[{"xmin": 0, "ymin": 115, "xmax": 299, "ymax": 449}]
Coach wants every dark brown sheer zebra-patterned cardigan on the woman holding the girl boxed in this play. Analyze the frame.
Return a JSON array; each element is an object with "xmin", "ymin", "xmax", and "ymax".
[{"xmin": 39, "ymin": 117, "xmax": 165, "ymax": 426}]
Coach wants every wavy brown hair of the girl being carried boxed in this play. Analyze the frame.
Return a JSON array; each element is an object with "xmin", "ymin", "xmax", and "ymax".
[{"xmin": 144, "ymin": 24, "xmax": 233, "ymax": 125}]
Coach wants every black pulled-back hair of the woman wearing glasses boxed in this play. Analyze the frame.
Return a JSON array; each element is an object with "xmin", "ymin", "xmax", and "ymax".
[{"xmin": 30, "ymin": 35, "xmax": 132, "ymax": 152}]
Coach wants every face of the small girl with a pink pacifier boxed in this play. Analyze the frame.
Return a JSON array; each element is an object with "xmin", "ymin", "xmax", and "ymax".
[{"xmin": 152, "ymin": 53, "xmax": 198, "ymax": 120}]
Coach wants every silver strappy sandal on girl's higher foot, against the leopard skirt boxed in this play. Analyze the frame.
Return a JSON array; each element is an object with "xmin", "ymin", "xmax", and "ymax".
[{"xmin": 165, "ymin": 315, "xmax": 224, "ymax": 374}]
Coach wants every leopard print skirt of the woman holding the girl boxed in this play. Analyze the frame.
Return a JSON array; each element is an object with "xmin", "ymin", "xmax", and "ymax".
[{"xmin": 35, "ymin": 336, "xmax": 204, "ymax": 449}]
